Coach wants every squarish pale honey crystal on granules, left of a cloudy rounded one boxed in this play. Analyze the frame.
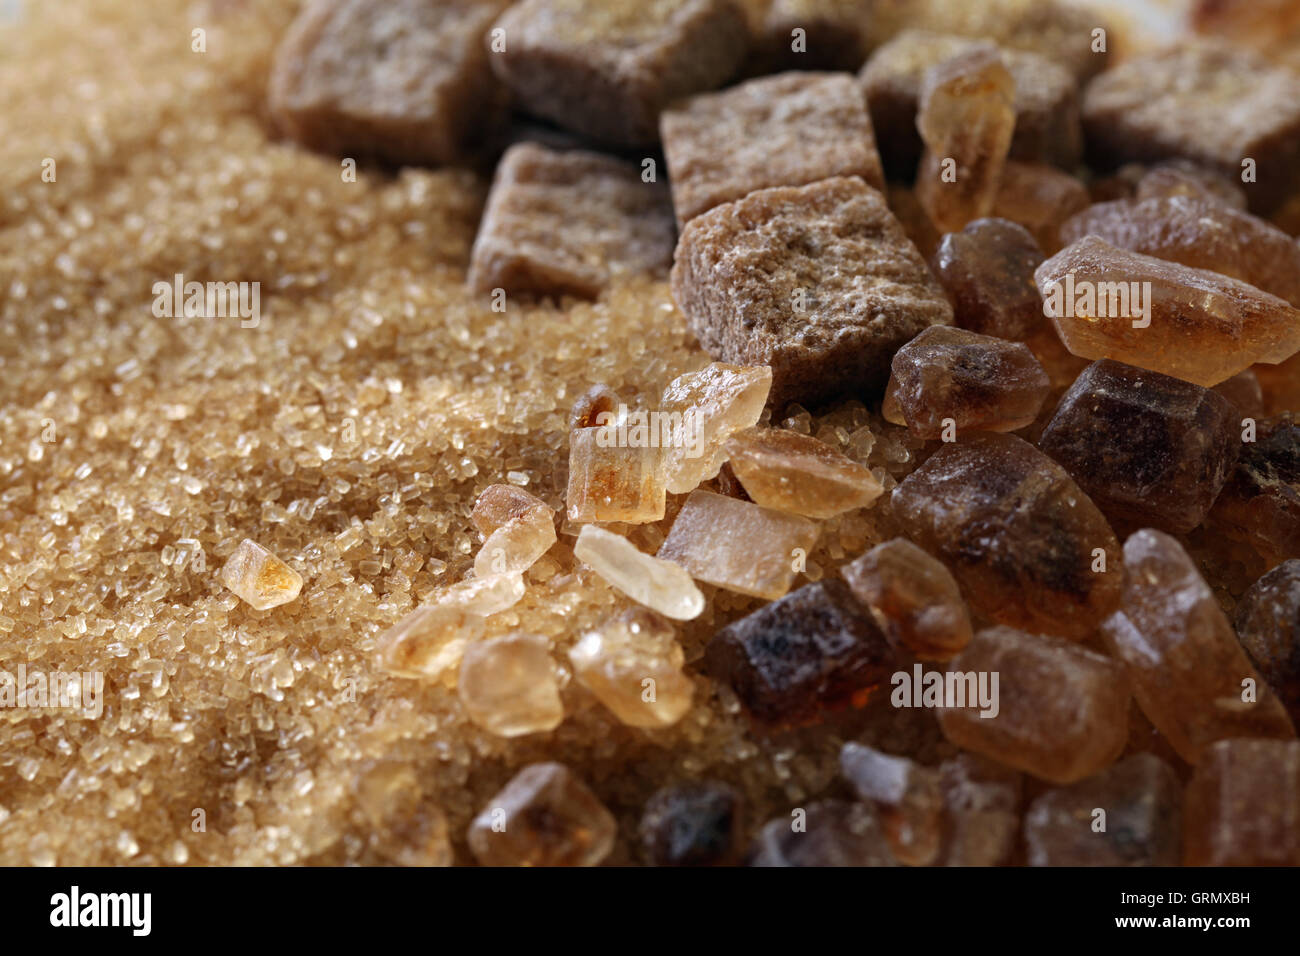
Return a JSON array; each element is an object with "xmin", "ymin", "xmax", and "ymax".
[{"xmin": 458, "ymin": 633, "xmax": 564, "ymax": 737}]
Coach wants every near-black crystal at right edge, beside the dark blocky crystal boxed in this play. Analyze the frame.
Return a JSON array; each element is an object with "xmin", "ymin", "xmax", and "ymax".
[{"xmin": 1210, "ymin": 414, "xmax": 1300, "ymax": 567}]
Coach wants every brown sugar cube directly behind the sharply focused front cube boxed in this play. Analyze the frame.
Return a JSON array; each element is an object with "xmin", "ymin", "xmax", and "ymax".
[{"xmin": 659, "ymin": 73, "xmax": 884, "ymax": 225}]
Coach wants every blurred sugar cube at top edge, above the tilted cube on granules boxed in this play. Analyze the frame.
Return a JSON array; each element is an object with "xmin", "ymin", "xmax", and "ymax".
[{"xmin": 491, "ymin": 0, "xmax": 749, "ymax": 146}]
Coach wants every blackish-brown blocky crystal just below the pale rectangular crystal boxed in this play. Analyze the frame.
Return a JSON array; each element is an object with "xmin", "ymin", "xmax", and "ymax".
[{"xmin": 705, "ymin": 579, "xmax": 894, "ymax": 727}]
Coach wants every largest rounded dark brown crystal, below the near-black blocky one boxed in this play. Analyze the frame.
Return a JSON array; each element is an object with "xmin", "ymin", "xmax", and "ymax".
[{"xmin": 892, "ymin": 433, "xmax": 1119, "ymax": 640}]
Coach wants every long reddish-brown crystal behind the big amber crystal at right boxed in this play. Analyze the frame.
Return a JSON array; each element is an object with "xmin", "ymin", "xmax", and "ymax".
[{"xmin": 1061, "ymin": 195, "xmax": 1300, "ymax": 306}]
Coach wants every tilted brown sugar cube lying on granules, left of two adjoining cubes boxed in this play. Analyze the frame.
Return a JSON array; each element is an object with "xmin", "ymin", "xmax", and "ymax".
[{"xmin": 469, "ymin": 143, "xmax": 675, "ymax": 298}]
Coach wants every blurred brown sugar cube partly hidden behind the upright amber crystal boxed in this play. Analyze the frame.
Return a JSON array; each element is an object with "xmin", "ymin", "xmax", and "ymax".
[{"xmin": 858, "ymin": 30, "xmax": 1083, "ymax": 178}]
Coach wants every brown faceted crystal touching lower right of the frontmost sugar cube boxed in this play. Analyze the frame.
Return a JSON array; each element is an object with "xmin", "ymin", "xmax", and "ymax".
[{"xmin": 883, "ymin": 325, "xmax": 1052, "ymax": 438}]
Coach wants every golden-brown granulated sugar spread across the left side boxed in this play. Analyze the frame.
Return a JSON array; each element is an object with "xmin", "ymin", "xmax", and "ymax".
[{"xmin": 0, "ymin": 0, "xmax": 935, "ymax": 865}]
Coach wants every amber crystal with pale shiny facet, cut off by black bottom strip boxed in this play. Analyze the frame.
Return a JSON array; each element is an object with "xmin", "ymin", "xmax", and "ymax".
[{"xmin": 468, "ymin": 763, "xmax": 618, "ymax": 866}]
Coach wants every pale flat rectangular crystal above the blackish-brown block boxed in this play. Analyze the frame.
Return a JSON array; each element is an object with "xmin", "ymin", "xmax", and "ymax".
[{"xmin": 659, "ymin": 490, "xmax": 818, "ymax": 601}]
